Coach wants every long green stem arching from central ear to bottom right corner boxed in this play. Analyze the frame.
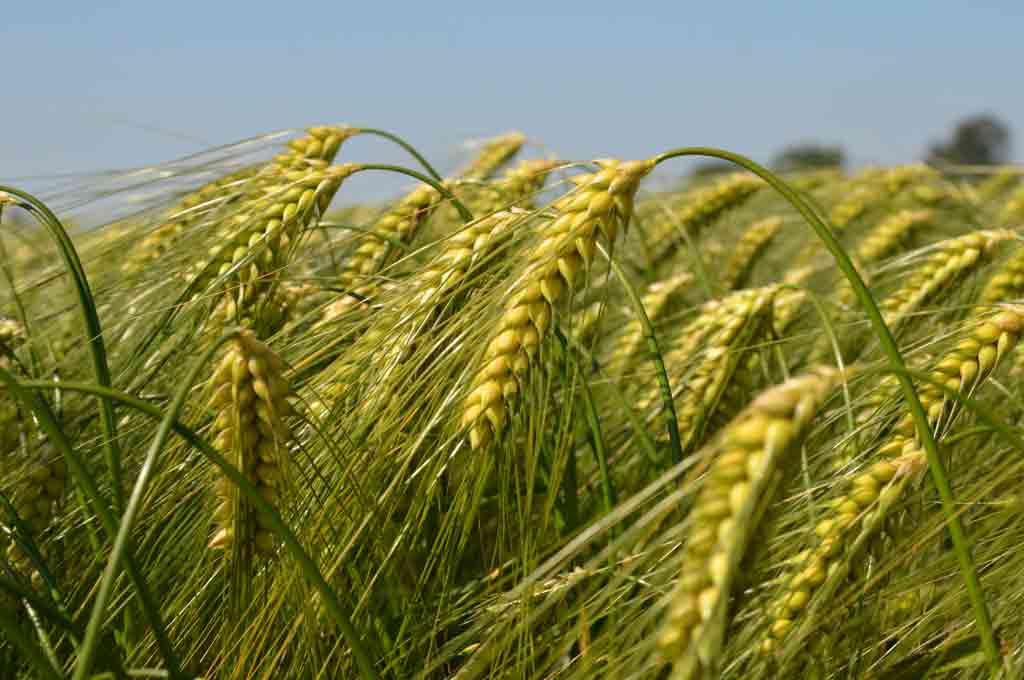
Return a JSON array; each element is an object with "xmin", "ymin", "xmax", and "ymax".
[{"xmin": 654, "ymin": 146, "xmax": 1002, "ymax": 675}]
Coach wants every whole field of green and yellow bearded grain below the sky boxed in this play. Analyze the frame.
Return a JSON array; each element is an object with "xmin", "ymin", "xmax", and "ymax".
[{"xmin": 0, "ymin": 126, "xmax": 1024, "ymax": 680}]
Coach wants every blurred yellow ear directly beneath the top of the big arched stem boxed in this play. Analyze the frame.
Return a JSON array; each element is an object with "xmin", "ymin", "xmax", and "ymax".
[{"xmin": 651, "ymin": 172, "xmax": 765, "ymax": 261}]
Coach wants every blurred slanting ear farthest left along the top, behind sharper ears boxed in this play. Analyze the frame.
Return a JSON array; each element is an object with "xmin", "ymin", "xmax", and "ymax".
[{"xmin": 121, "ymin": 166, "xmax": 259, "ymax": 273}]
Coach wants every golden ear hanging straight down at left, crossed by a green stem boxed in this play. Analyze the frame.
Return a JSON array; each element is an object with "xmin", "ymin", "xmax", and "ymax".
[{"xmin": 210, "ymin": 331, "xmax": 292, "ymax": 555}]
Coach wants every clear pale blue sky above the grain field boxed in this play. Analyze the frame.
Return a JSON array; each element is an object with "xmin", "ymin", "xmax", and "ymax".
[{"xmin": 0, "ymin": 0, "xmax": 1024, "ymax": 188}]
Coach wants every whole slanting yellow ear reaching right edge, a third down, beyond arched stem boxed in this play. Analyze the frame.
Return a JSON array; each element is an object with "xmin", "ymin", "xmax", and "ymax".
[{"xmin": 880, "ymin": 229, "xmax": 1017, "ymax": 332}]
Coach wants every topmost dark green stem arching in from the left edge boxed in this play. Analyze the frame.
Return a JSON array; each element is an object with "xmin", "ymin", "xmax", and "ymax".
[{"xmin": 0, "ymin": 186, "xmax": 124, "ymax": 510}]
